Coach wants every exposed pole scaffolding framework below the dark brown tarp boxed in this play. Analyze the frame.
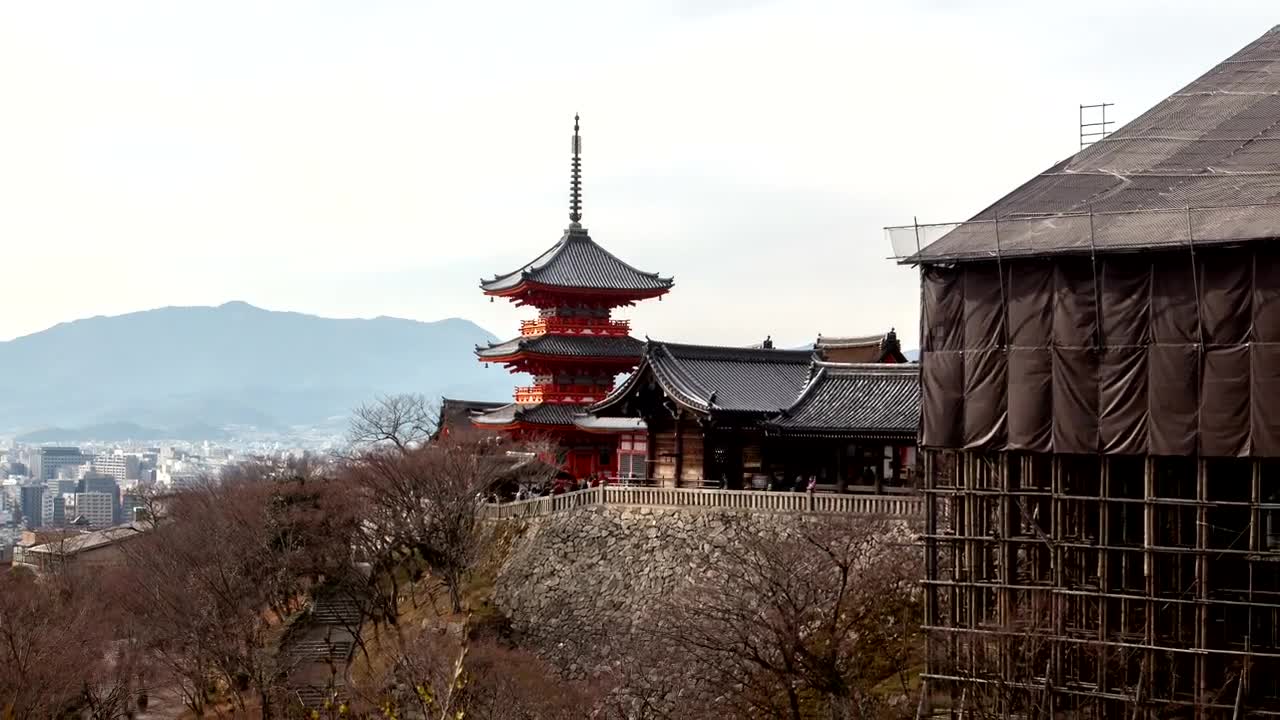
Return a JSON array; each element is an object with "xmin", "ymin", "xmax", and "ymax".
[{"xmin": 924, "ymin": 451, "xmax": 1280, "ymax": 717}]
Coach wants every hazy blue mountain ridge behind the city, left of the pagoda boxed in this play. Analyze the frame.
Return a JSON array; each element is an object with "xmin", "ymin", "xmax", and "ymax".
[{"xmin": 0, "ymin": 302, "xmax": 513, "ymax": 430}]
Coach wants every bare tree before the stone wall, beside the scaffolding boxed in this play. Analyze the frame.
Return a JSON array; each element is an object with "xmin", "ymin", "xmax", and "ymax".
[{"xmin": 645, "ymin": 519, "xmax": 922, "ymax": 720}]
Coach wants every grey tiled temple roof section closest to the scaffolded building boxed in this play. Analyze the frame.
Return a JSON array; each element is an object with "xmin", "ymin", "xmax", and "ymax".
[{"xmin": 767, "ymin": 363, "xmax": 920, "ymax": 437}]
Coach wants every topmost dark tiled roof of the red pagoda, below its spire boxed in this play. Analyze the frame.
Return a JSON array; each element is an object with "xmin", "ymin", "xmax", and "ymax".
[{"xmin": 480, "ymin": 227, "xmax": 673, "ymax": 295}]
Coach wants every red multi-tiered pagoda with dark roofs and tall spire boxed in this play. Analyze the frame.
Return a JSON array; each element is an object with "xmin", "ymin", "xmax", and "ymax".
[{"xmin": 472, "ymin": 115, "xmax": 672, "ymax": 478}]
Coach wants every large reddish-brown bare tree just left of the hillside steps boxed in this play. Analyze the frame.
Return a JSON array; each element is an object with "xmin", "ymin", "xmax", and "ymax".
[{"xmin": 119, "ymin": 456, "xmax": 356, "ymax": 717}]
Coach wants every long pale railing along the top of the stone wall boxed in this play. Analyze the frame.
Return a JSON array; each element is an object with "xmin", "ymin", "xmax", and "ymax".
[{"xmin": 483, "ymin": 486, "xmax": 924, "ymax": 520}]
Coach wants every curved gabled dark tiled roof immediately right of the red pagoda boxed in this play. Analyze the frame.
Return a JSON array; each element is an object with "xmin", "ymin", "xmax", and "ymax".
[{"xmin": 594, "ymin": 342, "xmax": 812, "ymax": 414}]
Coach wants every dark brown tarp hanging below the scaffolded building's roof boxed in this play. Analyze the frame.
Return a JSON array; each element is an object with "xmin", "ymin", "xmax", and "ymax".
[{"xmin": 920, "ymin": 243, "xmax": 1280, "ymax": 457}]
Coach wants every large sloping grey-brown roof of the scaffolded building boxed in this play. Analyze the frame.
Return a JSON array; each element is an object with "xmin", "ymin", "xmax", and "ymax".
[{"xmin": 908, "ymin": 27, "xmax": 1280, "ymax": 263}]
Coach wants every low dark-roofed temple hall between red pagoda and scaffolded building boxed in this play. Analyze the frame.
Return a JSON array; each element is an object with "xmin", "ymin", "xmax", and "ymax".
[{"xmin": 579, "ymin": 341, "xmax": 920, "ymax": 492}]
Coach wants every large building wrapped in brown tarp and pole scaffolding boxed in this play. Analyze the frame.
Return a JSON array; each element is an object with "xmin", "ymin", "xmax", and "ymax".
[{"xmin": 890, "ymin": 28, "xmax": 1280, "ymax": 717}]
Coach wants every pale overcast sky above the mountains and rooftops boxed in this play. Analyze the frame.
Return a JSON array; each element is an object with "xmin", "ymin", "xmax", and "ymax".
[{"xmin": 0, "ymin": 0, "xmax": 1280, "ymax": 346}]
